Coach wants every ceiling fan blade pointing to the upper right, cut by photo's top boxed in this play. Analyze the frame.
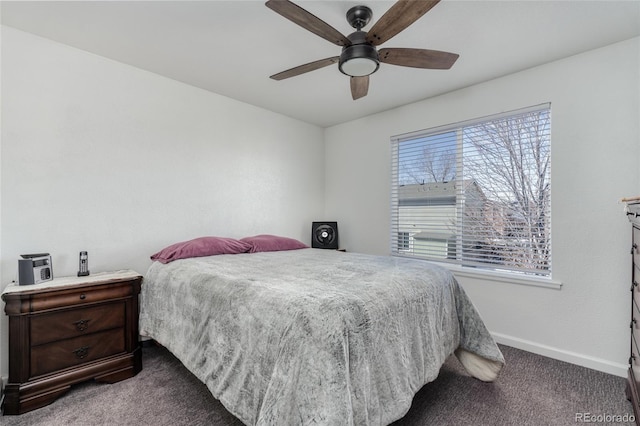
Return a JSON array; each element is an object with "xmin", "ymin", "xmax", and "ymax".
[{"xmin": 367, "ymin": 0, "xmax": 440, "ymax": 46}]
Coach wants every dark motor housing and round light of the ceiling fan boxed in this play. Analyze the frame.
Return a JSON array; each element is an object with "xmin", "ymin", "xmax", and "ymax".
[{"xmin": 338, "ymin": 31, "xmax": 380, "ymax": 77}]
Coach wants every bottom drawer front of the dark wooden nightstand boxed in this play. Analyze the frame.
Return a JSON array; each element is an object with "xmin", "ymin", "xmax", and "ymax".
[{"xmin": 31, "ymin": 328, "xmax": 125, "ymax": 377}]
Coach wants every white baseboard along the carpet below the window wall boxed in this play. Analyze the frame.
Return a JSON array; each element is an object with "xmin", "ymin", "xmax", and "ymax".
[{"xmin": 491, "ymin": 333, "xmax": 629, "ymax": 377}]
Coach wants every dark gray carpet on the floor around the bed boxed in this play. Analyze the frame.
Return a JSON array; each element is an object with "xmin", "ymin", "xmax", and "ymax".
[{"xmin": 0, "ymin": 346, "xmax": 633, "ymax": 426}]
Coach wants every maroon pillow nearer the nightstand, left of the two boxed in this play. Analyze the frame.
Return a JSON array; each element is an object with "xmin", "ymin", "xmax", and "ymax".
[{"xmin": 151, "ymin": 237, "xmax": 251, "ymax": 263}]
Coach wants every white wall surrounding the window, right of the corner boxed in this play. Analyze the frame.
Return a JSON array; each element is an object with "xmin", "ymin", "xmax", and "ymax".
[{"xmin": 325, "ymin": 38, "xmax": 640, "ymax": 375}]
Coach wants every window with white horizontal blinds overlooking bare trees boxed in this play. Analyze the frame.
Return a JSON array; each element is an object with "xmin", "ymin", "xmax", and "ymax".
[{"xmin": 391, "ymin": 104, "xmax": 551, "ymax": 276}]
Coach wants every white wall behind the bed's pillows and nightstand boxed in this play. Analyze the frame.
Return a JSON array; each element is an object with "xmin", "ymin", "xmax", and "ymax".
[{"xmin": 0, "ymin": 27, "xmax": 324, "ymax": 377}]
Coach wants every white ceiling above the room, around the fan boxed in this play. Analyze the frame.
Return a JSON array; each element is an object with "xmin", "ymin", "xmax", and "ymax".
[{"xmin": 1, "ymin": 0, "xmax": 640, "ymax": 127}]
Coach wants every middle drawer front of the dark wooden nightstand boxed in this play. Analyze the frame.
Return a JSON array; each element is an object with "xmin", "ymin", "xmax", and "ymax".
[{"xmin": 31, "ymin": 302, "xmax": 125, "ymax": 346}]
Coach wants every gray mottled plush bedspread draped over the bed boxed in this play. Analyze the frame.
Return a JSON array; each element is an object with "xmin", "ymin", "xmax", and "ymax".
[{"xmin": 140, "ymin": 248, "xmax": 504, "ymax": 425}]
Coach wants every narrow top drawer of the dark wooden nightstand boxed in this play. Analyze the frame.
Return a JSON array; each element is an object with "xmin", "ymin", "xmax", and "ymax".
[{"xmin": 31, "ymin": 286, "xmax": 132, "ymax": 312}]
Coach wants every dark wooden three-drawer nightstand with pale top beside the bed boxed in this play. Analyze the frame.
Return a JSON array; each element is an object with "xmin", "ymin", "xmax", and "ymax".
[{"xmin": 2, "ymin": 271, "xmax": 142, "ymax": 414}]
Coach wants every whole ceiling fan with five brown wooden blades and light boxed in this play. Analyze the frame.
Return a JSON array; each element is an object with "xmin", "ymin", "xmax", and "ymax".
[{"xmin": 266, "ymin": 0, "xmax": 459, "ymax": 100}]
